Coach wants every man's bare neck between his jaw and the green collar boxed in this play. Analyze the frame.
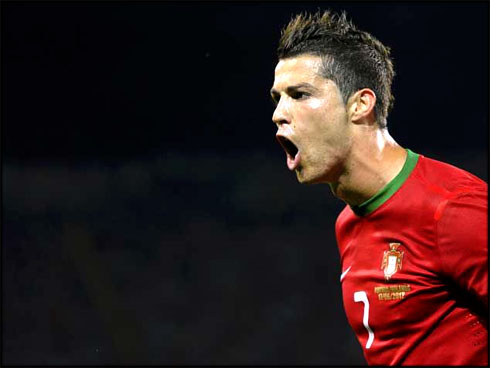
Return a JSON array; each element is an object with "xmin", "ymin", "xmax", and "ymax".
[{"xmin": 330, "ymin": 127, "xmax": 407, "ymax": 206}]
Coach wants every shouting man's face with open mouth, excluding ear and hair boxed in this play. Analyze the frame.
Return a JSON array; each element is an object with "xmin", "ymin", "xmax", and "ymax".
[{"xmin": 271, "ymin": 55, "xmax": 351, "ymax": 184}]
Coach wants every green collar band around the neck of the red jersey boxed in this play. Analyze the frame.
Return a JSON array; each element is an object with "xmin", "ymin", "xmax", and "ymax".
[{"xmin": 350, "ymin": 149, "xmax": 419, "ymax": 216}]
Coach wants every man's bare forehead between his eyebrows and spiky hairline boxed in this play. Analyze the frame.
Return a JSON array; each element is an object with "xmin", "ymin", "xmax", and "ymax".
[{"xmin": 274, "ymin": 55, "xmax": 326, "ymax": 89}]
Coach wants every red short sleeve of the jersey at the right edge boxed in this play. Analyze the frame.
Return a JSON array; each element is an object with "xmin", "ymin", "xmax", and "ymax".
[{"xmin": 437, "ymin": 190, "xmax": 488, "ymax": 308}]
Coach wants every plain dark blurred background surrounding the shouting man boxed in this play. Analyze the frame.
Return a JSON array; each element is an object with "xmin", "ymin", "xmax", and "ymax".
[{"xmin": 1, "ymin": 1, "xmax": 489, "ymax": 365}]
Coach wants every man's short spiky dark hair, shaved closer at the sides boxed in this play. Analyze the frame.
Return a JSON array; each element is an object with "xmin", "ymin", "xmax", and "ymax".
[{"xmin": 277, "ymin": 10, "xmax": 395, "ymax": 128}]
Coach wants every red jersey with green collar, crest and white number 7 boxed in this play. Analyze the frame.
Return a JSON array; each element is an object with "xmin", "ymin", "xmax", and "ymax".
[{"xmin": 336, "ymin": 150, "xmax": 488, "ymax": 365}]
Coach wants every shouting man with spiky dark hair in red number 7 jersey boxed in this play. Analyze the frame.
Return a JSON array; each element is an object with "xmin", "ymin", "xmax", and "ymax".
[{"xmin": 271, "ymin": 11, "xmax": 488, "ymax": 365}]
